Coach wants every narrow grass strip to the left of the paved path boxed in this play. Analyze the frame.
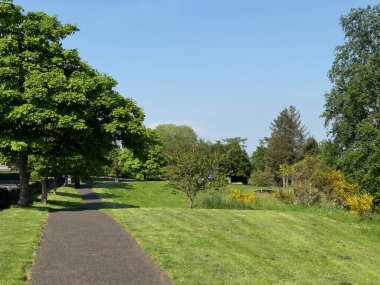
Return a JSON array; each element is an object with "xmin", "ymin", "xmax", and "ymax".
[{"xmin": 0, "ymin": 187, "xmax": 82, "ymax": 285}]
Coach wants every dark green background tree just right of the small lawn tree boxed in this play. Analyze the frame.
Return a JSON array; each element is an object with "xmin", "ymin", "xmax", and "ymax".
[{"xmin": 214, "ymin": 137, "xmax": 251, "ymax": 184}]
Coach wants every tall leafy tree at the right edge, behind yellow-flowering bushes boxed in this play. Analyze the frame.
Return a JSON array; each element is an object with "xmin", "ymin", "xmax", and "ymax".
[{"xmin": 323, "ymin": 5, "xmax": 380, "ymax": 201}]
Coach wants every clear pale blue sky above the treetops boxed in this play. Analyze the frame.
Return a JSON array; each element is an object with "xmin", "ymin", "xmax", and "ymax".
[{"xmin": 15, "ymin": 0, "xmax": 377, "ymax": 153}]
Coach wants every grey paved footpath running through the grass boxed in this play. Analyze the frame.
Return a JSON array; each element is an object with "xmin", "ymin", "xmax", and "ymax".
[{"xmin": 31, "ymin": 188, "xmax": 173, "ymax": 285}]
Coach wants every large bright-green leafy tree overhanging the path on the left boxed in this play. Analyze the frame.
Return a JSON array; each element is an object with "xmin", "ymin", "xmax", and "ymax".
[{"xmin": 0, "ymin": 0, "xmax": 144, "ymax": 205}]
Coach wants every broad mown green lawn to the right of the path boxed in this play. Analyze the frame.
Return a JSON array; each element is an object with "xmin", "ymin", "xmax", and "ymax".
[{"xmin": 95, "ymin": 182, "xmax": 380, "ymax": 285}]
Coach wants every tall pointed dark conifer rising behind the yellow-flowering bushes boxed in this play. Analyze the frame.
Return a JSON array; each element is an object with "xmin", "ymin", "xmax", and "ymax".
[{"xmin": 265, "ymin": 106, "xmax": 307, "ymax": 176}]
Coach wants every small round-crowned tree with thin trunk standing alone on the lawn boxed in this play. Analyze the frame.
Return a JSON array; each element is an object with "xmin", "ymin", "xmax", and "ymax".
[{"xmin": 166, "ymin": 141, "xmax": 225, "ymax": 208}]
